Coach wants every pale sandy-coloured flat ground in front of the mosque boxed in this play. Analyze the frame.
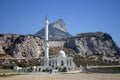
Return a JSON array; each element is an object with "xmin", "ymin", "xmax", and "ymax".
[{"xmin": 0, "ymin": 73, "xmax": 120, "ymax": 80}]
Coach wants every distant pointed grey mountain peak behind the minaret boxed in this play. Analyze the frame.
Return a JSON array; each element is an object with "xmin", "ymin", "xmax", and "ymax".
[{"xmin": 35, "ymin": 19, "xmax": 71, "ymax": 40}]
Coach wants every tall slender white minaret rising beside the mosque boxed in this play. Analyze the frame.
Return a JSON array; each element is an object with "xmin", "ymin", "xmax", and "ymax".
[{"xmin": 45, "ymin": 16, "xmax": 49, "ymax": 59}]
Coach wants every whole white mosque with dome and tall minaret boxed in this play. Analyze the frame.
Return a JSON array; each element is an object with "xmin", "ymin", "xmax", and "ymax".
[{"xmin": 15, "ymin": 17, "xmax": 75, "ymax": 73}]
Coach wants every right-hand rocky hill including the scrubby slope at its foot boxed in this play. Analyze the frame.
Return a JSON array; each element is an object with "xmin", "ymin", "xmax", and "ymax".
[{"xmin": 64, "ymin": 32, "xmax": 120, "ymax": 65}]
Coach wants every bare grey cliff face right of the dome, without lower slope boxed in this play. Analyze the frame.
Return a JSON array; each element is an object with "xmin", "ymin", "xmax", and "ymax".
[{"xmin": 65, "ymin": 32, "xmax": 120, "ymax": 56}]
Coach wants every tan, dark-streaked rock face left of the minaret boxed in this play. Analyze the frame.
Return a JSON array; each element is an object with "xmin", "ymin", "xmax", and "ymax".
[{"xmin": 0, "ymin": 34, "xmax": 43, "ymax": 58}]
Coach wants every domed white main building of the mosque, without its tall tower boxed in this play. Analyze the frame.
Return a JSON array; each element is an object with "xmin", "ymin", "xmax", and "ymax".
[{"xmin": 39, "ymin": 50, "xmax": 75, "ymax": 72}]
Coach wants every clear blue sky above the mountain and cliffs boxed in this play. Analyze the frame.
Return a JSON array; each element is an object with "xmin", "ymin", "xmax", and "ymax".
[{"xmin": 0, "ymin": 0, "xmax": 120, "ymax": 47}]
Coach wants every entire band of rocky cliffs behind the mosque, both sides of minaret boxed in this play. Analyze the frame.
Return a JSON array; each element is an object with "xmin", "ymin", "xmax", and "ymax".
[{"xmin": 0, "ymin": 32, "xmax": 120, "ymax": 66}]
